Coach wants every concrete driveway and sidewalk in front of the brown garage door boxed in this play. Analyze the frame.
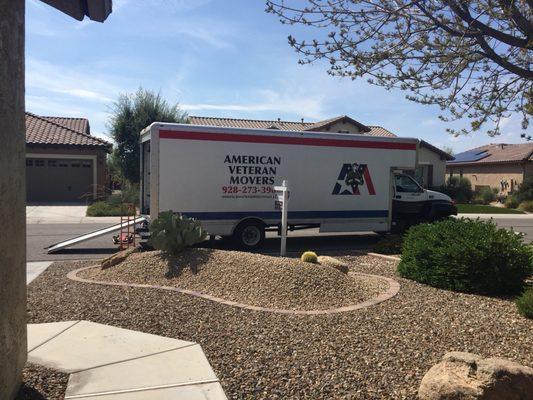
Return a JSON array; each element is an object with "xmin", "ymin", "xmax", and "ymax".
[{"xmin": 26, "ymin": 204, "xmax": 120, "ymax": 224}]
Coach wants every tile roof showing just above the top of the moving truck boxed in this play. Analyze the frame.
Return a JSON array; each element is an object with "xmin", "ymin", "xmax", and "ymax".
[{"xmin": 189, "ymin": 115, "xmax": 396, "ymax": 137}]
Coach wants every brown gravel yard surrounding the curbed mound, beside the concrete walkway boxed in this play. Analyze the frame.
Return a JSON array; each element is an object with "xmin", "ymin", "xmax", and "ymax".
[{"xmin": 28, "ymin": 256, "xmax": 533, "ymax": 399}]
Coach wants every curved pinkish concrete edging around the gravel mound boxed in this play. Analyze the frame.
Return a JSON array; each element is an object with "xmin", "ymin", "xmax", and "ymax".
[{"xmin": 67, "ymin": 265, "xmax": 400, "ymax": 315}]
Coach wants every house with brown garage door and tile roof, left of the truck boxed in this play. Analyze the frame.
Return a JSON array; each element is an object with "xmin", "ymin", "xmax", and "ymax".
[{"xmin": 26, "ymin": 112, "xmax": 111, "ymax": 202}]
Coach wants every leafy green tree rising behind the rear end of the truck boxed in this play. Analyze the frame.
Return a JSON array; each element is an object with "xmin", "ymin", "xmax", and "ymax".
[{"xmin": 109, "ymin": 88, "xmax": 188, "ymax": 183}]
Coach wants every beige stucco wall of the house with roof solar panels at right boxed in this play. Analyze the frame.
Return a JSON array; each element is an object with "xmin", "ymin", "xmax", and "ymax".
[{"xmin": 446, "ymin": 163, "xmax": 533, "ymax": 194}]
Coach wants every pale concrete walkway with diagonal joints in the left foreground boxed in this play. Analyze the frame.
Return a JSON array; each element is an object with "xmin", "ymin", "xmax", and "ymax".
[{"xmin": 28, "ymin": 321, "xmax": 226, "ymax": 400}]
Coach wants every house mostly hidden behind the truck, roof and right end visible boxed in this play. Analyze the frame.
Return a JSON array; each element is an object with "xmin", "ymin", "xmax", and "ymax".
[{"xmin": 189, "ymin": 115, "xmax": 453, "ymax": 187}]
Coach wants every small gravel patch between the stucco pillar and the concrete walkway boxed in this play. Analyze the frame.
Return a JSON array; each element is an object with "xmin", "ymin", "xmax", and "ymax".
[{"xmin": 15, "ymin": 363, "xmax": 69, "ymax": 400}]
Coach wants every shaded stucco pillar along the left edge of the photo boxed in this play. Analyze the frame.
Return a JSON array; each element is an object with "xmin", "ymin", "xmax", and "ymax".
[{"xmin": 0, "ymin": 0, "xmax": 27, "ymax": 400}]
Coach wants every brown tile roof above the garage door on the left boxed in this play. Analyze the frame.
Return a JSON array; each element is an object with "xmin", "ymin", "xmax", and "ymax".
[{"xmin": 26, "ymin": 112, "xmax": 111, "ymax": 149}]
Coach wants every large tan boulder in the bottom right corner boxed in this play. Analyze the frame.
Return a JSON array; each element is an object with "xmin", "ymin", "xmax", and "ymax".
[{"xmin": 418, "ymin": 352, "xmax": 533, "ymax": 400}]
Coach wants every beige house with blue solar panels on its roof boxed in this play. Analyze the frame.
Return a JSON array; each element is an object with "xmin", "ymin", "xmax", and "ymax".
[{"xmin": 446, "ymin": 143, "xmax": 533, "ymax": 194}]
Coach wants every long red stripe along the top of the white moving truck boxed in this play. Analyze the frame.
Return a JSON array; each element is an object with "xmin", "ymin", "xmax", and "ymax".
[{"xmin": 159, "ymin": 130, "xmax": 416, "ymax": 150}]
